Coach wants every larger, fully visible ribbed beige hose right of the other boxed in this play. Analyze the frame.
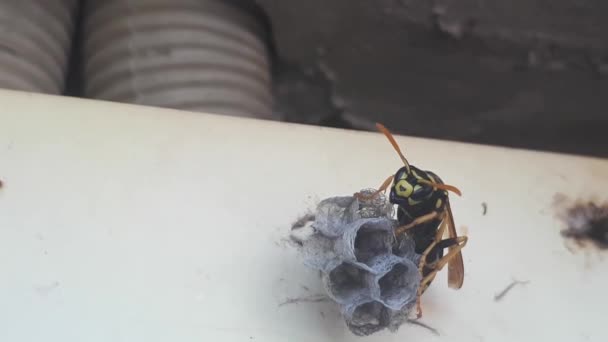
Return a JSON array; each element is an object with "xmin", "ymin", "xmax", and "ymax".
[{"xmin": 83, "ymin": 0, "xmax": 273, "ymax": 119}]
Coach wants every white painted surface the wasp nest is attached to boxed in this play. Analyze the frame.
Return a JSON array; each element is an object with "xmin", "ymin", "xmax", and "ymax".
[{"xmin": 0, "ymin": 92, "xmax": 608, "ymax": 342}]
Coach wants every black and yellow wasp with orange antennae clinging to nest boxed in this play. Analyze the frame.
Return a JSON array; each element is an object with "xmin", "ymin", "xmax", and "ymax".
[{"xmin": 355, "ymin": 123, "xmax": 467, "ymax": 318}]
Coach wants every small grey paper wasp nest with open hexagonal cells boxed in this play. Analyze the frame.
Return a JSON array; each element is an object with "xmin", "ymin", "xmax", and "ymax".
[{"xmin": 292, "ymin": 190, "xmax": 420, "ymax": 336}]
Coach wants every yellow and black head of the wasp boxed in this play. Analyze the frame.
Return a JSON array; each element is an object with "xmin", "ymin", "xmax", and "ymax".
[{"xmin": 390, "ymin": 165, "xmax": 447, "ymax": 209}]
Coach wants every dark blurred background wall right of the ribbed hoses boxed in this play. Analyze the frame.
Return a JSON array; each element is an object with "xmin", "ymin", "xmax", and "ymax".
[{"xmin": 258, "ymin": 0, "xmax": 608, "ymax": 157}]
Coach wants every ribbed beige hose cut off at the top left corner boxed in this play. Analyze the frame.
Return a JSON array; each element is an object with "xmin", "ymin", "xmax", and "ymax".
[{"xmin": 0, "ymin": 0, "xmax": 77, "ymax": 94}]
